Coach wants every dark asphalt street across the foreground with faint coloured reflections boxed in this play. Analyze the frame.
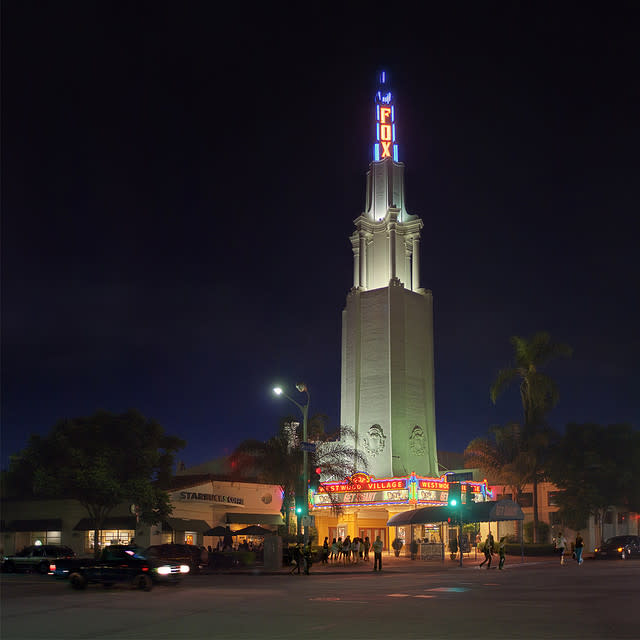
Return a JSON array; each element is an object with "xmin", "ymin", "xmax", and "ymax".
[{"xmin": 0, "ymin": 556, "xmax": 640, "ymax": 640}]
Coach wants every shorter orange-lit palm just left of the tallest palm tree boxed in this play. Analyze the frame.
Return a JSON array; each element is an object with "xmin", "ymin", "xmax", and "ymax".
[{"xmin": 464, "ymin": 423, "xmax": 531, "ymax": 537}]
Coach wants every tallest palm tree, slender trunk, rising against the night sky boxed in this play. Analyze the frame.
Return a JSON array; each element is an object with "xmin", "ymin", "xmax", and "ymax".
[{"xmin": 490, "ymin": 331, "xmax": 572, "ymax": 542}]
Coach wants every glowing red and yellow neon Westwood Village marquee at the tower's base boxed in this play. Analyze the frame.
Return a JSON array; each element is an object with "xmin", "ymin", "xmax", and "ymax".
[{"xmin": 311, "ymin": 473, "xmax": 488, "ymax": 509}]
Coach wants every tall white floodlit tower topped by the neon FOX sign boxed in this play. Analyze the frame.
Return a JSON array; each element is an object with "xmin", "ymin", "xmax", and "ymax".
[{"xmin": 340, "ymin": 72, "xmax": 439, "ymax": 478}]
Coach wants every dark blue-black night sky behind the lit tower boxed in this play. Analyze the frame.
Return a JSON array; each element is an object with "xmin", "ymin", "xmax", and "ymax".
[{"xmin": 2, "ymin": 0, "xmax": 640, "ymax": 467}]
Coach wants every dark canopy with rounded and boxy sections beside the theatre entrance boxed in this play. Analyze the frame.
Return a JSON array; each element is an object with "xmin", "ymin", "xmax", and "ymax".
[{"xmin": 387, "ymin": 500, "xmax": 524, "ymax": 527}]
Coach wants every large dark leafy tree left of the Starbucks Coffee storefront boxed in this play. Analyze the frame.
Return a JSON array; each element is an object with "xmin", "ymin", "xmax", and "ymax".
[{"xmin": 7, "ymin": 409, "xmax": 185, "ymax": 553}]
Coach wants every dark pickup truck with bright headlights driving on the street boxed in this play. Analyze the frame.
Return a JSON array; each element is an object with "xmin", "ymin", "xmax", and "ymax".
[{"xmin": 49, "ymin": 545, "xmax": 189, "ymax": 591}]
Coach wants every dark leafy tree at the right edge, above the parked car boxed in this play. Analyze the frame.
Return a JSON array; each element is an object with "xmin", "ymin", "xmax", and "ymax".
[{"xmin": 548, "ymin": 423, "xmax": 640, "ymax": 539}]
